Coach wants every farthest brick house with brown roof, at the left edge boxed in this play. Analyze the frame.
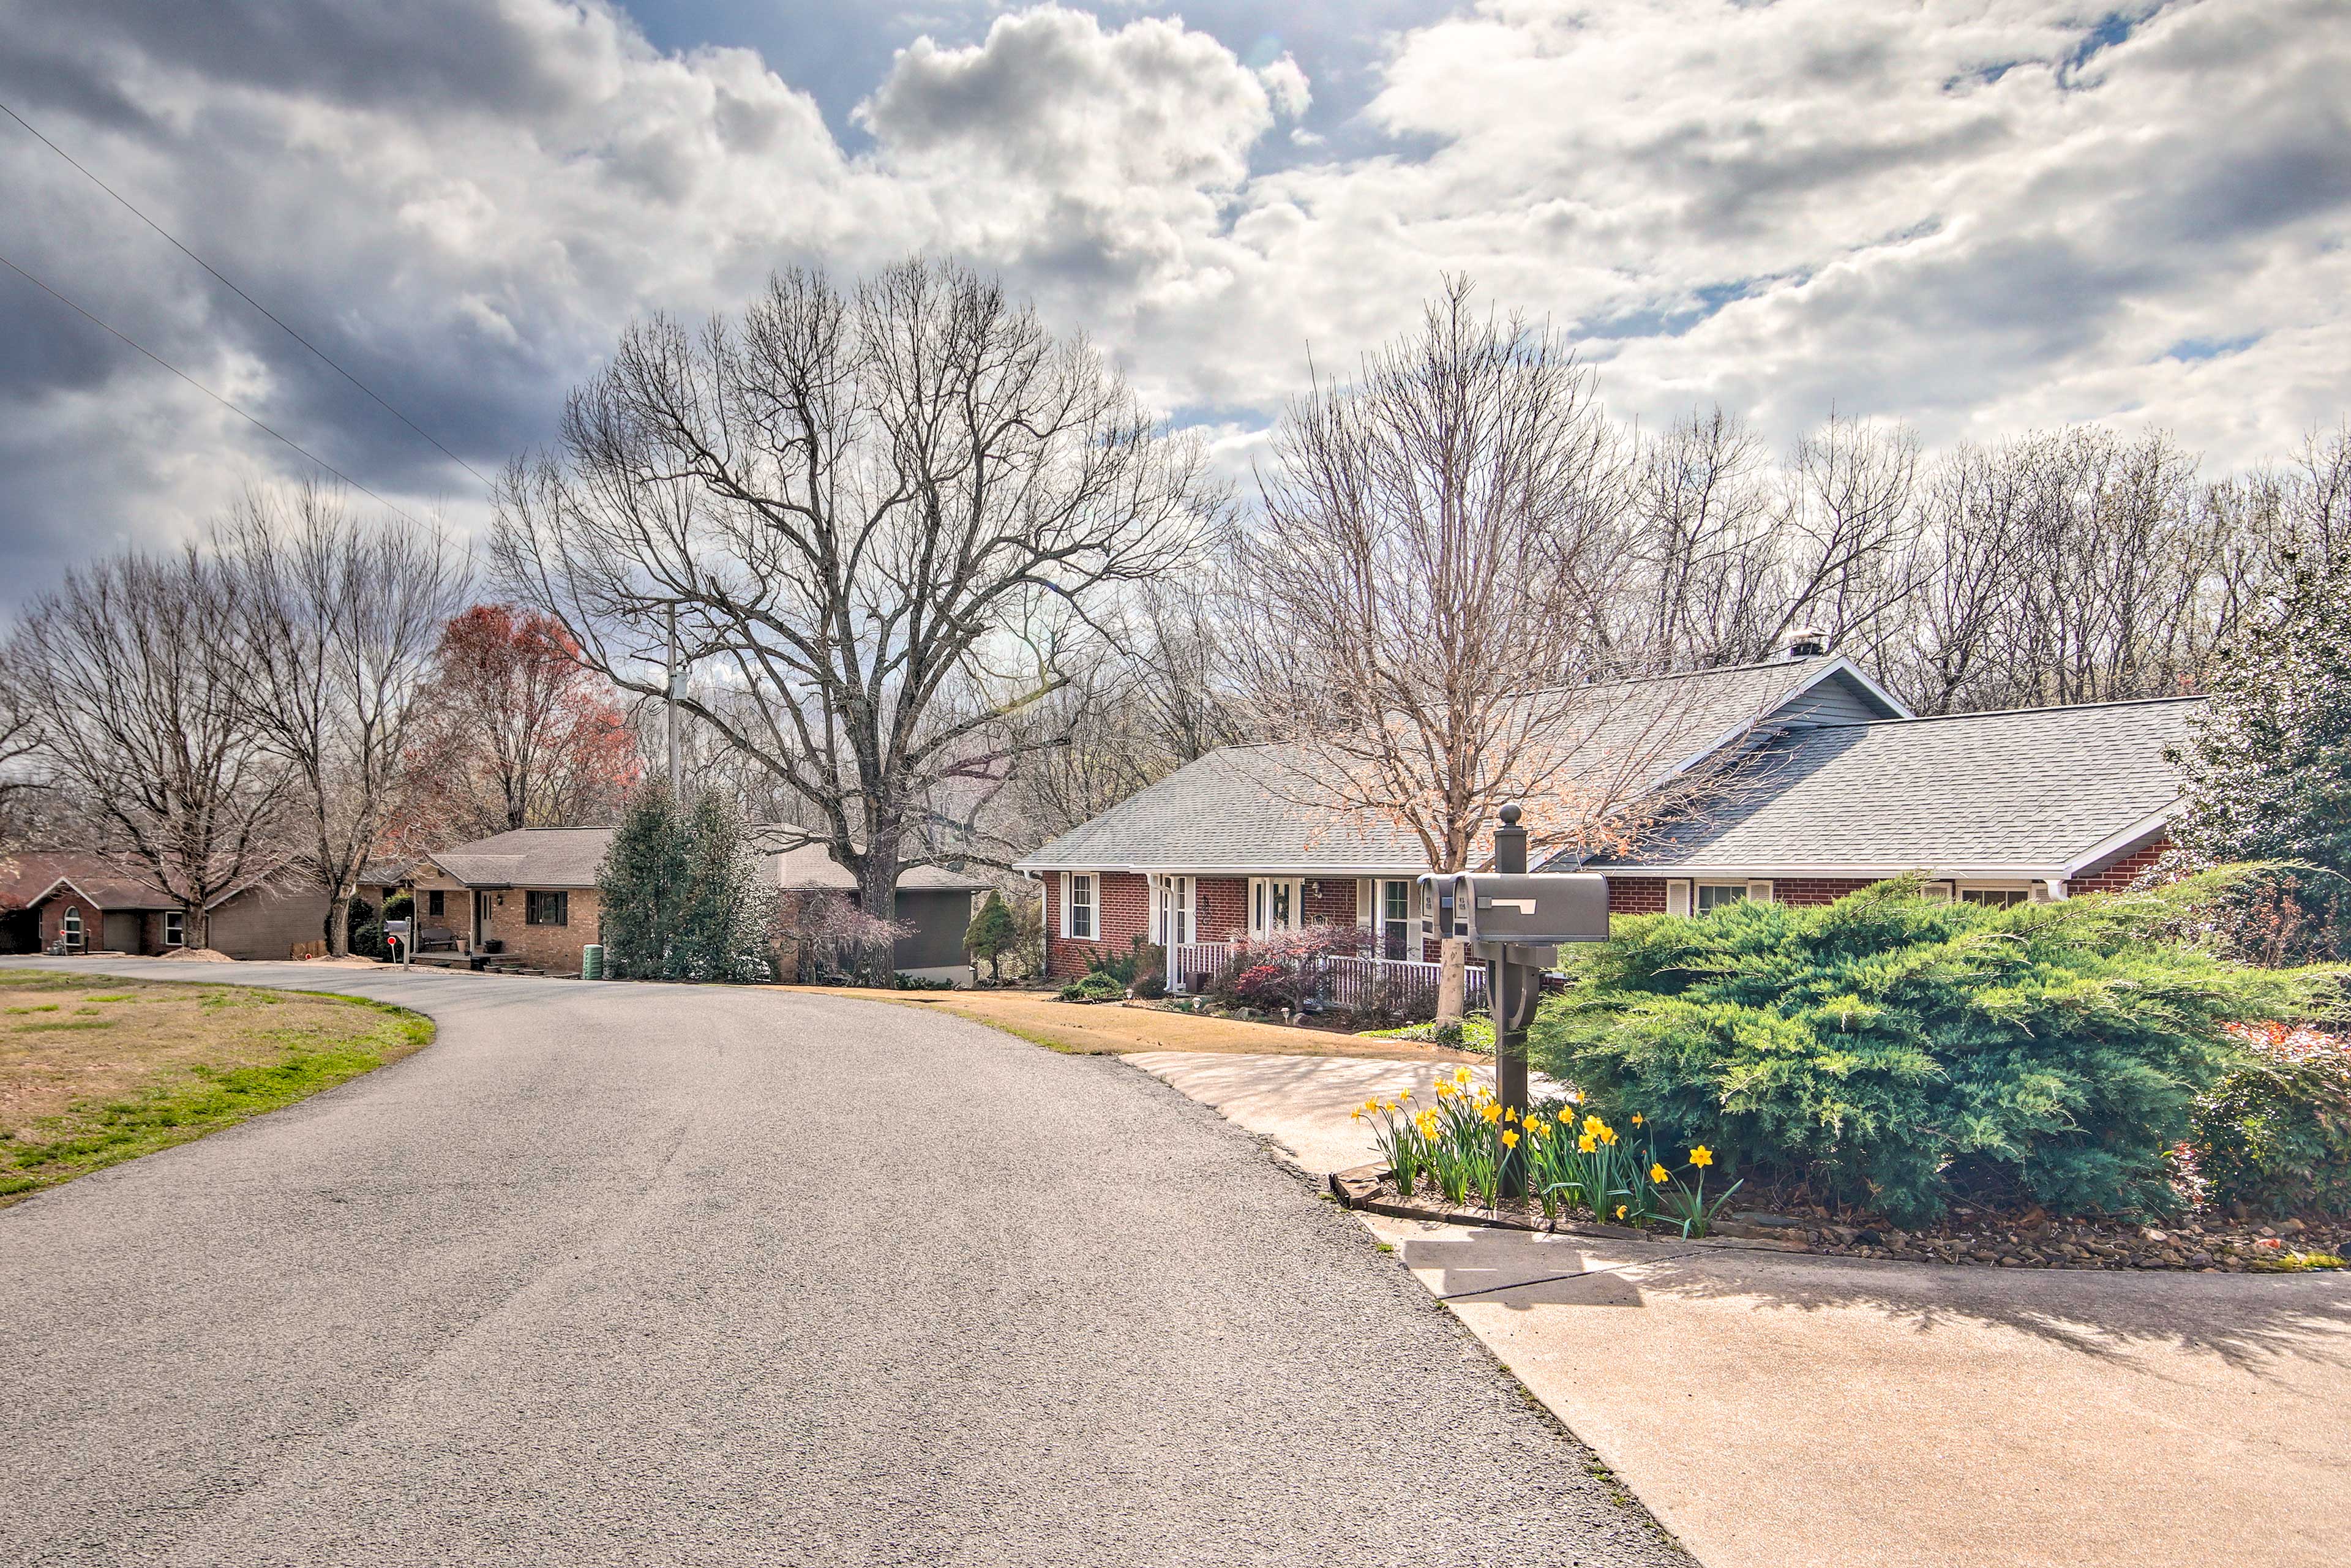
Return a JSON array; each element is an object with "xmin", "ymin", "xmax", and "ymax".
[{"xmin": 0, "ymin": 849, "xmax": 327, "ymax": 959}]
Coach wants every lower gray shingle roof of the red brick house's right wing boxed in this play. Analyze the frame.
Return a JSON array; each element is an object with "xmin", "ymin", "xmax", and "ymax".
[{"xmin": 1587, "ymin": 698, "xmax": 2203, "ymax": 877}]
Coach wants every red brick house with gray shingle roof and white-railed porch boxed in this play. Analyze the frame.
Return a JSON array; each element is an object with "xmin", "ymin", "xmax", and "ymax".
[{"xmin": 1016, "ymin": 653, "xmax": 2200, "ymax": 989}]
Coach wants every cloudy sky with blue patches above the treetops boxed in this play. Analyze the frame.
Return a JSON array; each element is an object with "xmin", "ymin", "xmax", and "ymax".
[{"xmin": 0, "ymin": 0, "xmax": 2351, "ymax": 599}]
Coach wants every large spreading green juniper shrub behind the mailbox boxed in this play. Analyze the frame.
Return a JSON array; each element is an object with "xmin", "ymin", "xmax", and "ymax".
[{"xmin": 1531, "ymin": 872, "xmax": 2332, "ymax": 1223}]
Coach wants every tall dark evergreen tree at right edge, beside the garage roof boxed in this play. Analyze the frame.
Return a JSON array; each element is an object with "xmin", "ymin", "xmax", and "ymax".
[{"xmin": 2172, "ymin": 560, "xmax": 2351, "ymax": 961}]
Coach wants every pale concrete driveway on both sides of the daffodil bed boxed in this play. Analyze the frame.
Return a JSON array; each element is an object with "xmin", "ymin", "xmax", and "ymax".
[{"xmin": 1131, "ymin": 1058, "xmax": 2351, "ymax": 1568}]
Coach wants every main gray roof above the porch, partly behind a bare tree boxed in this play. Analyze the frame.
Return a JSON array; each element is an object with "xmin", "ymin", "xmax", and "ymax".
[{"xmin": 1018, "ymin": 658, "xmax": 1900, "ymax": 874}]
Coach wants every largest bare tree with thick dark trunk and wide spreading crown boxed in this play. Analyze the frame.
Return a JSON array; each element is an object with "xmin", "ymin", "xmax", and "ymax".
[{"xmin": 493, "ymin": 261, "xmax": 1215, "ymax": 978}]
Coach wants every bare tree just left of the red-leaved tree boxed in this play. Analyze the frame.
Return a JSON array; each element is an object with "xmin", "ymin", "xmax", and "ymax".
[{"xmin": 221, "ymin": 484, "xmax": 468, "ymax": 957}]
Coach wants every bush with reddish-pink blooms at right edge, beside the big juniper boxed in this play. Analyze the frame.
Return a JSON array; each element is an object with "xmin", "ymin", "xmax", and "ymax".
[{"xmin": 2182, "ymin": 1022, "xmax": 2351, "ymax": 1215}]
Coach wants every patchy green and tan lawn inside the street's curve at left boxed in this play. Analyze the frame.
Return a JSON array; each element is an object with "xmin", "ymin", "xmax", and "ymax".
[{"xmin": 0, "ymin": 969, "xmax": 433, "ymax": 1204}]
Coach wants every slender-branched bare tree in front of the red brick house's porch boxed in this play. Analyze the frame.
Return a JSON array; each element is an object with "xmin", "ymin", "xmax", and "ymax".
[{"xmin": 1229, "ymin": 280, "xmax": 1651, "ymax": 1020}]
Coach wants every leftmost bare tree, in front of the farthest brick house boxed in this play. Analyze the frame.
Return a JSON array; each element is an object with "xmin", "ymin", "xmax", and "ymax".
[{"xmin": 7, "ymin": 548, "xmax": 294, "ymax": 947}]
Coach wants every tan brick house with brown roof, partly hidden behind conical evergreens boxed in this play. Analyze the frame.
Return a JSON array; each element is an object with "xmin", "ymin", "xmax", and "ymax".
[{"xmin": 409, "ymin": 828, "xmax": 983, "ymax": 985}]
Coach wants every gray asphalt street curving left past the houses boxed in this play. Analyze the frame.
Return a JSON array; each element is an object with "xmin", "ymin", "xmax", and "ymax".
[{"xmin": 0, "ymin": 961, "xmax": 1685, "ymax": 1566}]
